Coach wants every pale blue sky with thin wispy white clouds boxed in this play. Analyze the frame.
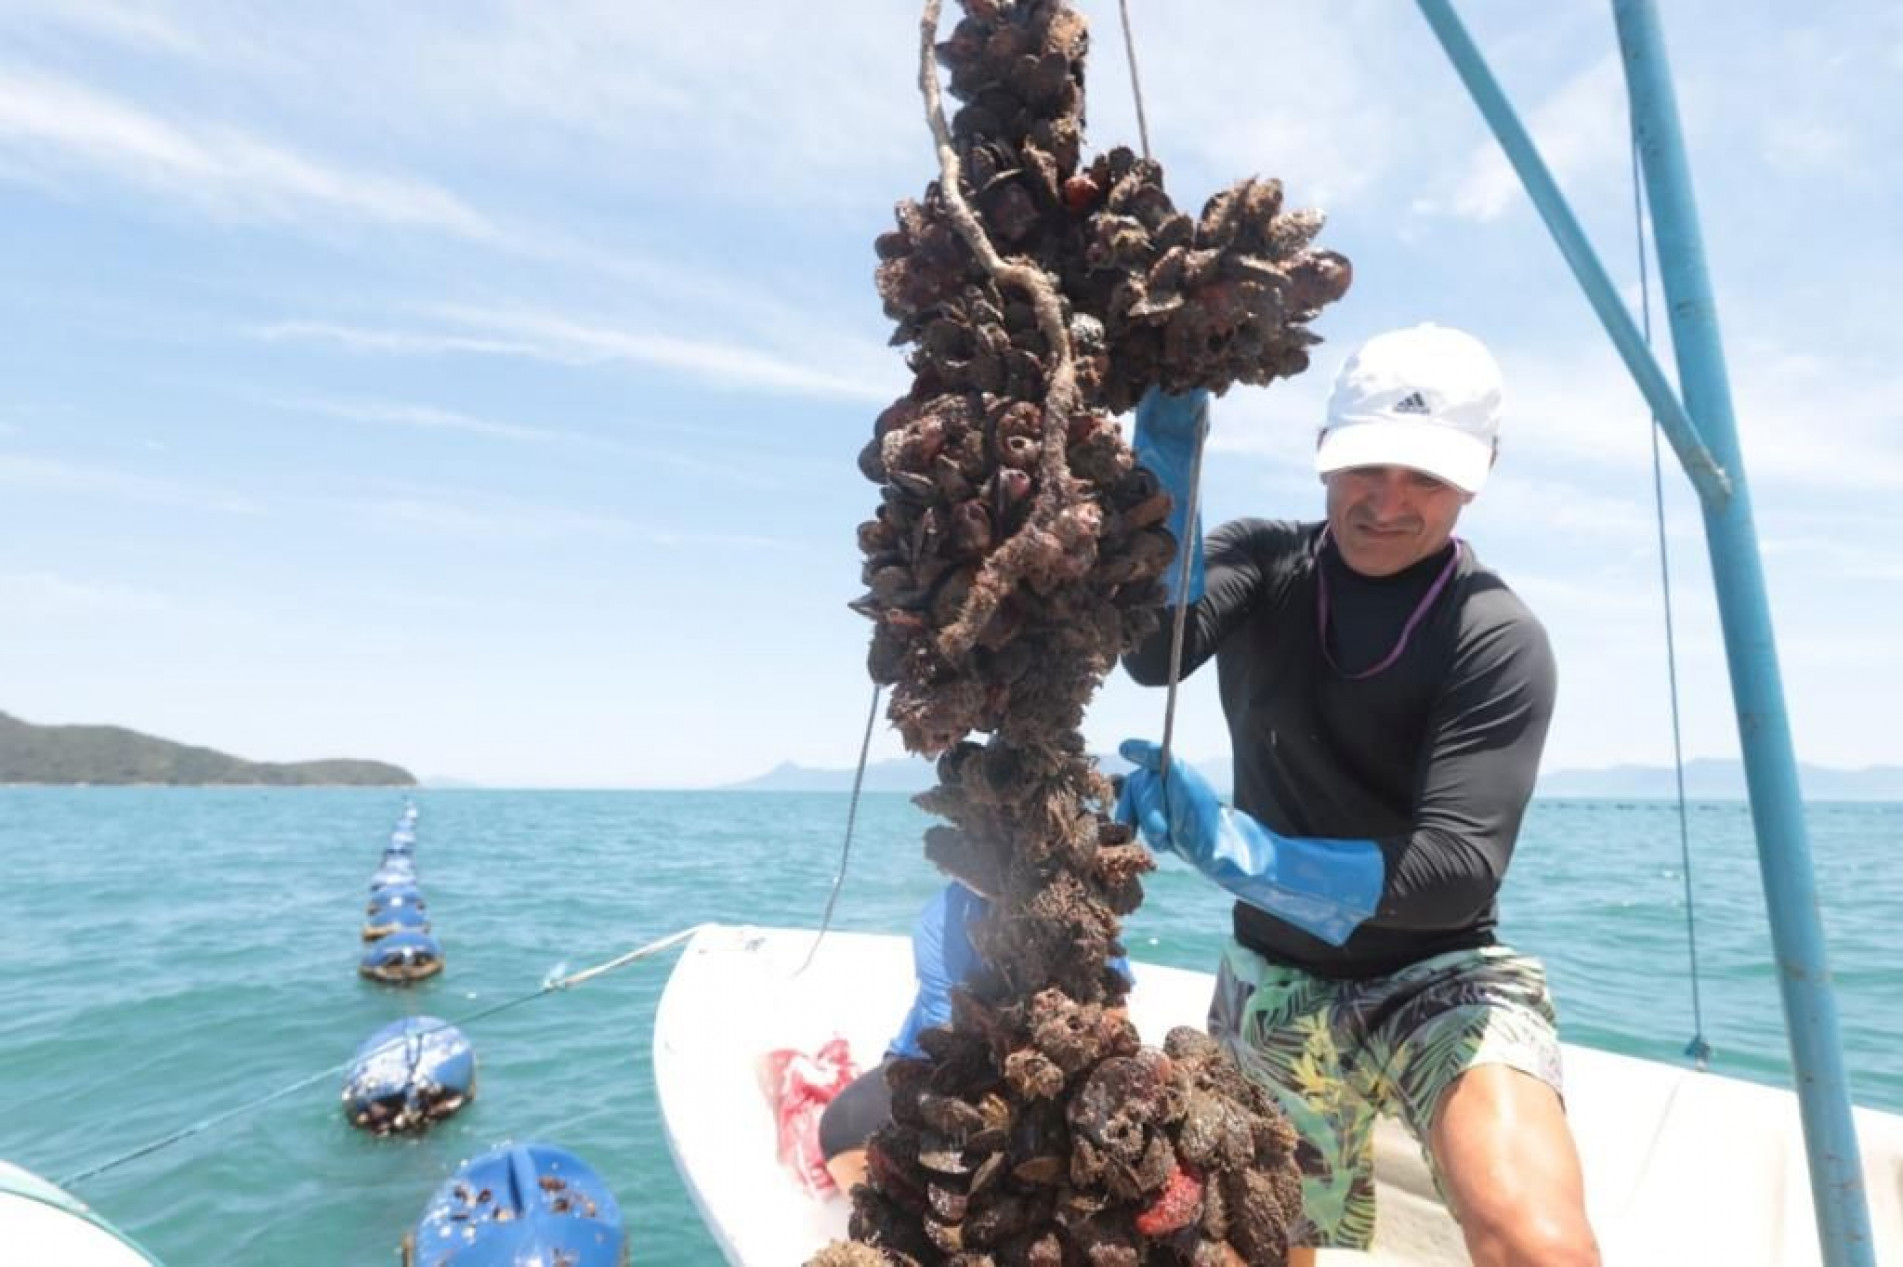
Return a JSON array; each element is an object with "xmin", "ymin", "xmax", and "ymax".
[{"xmin": 0, "ymin": 0, "xmax": 1903, "ymax": 788}]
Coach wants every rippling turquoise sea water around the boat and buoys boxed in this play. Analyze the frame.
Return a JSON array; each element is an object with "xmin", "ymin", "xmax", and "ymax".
[{"xmin": 0, "ymin": 788, "xmax": 1903, "ymax": 1267}]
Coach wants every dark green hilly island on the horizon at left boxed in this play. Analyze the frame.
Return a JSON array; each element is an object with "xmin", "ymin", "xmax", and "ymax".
[{"xmin": 0, "ymin": 713, "xmax": 417, "ymax": 788}]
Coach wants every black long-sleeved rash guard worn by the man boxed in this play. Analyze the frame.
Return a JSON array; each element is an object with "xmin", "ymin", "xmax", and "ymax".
[{"xmin": 1123, "ymin": 519, "xmax": 1555, "ymax": 978}]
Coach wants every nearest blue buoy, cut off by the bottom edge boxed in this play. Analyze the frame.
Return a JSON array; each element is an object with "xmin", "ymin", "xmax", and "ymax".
[{"xmin": 403, "ymin": 1143, "xmax": 628, "ymax": 1267}]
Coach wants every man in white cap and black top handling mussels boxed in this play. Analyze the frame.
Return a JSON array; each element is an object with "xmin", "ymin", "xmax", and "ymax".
[{"xmin": 1123, "ymin": 325, "xmax": 1599, "ymax": 1267}]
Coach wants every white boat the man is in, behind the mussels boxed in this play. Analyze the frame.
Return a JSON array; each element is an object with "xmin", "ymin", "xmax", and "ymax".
[{"xmin": 655, "ymin": 925, "xmax": 1903, "ymax": 1267}]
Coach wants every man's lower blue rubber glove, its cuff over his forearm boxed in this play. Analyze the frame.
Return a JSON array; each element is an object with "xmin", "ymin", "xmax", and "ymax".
[{"xmin": 1117, "ymin": 740, "xmax": 1387, "ymax": 945}]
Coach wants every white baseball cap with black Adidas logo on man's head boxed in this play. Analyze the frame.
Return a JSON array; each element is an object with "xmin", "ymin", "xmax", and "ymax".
[{"xmin": 1315, "ymin": 323, "xmax": 1501, "ymax": 493}]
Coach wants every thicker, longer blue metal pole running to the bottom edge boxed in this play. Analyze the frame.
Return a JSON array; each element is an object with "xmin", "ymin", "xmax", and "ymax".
[{"xmin": 1612, "ymin": 0, "xmax": 1876, "ymax": 1267}]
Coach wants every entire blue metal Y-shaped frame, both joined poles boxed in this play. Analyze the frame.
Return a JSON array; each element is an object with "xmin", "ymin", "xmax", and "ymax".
[{"xmin": 1418, "ymin": 0, "xmax": 1876, "ymax": 1267}]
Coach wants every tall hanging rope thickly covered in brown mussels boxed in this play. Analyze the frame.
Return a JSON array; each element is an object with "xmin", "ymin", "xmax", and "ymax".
[{"xmin": 837, "ymin": 0, "xmax": 1349, "ymax": 1267}]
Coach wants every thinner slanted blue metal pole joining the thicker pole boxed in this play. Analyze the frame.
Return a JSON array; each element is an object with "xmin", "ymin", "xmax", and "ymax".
[{"xmin": 1420, "ymin": 0, "xmax": 1730, "ymax": 506}]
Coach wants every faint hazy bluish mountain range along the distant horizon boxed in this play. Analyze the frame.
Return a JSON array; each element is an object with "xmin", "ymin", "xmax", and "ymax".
[{"xmin": 721, "ymin": 757, "xmax": 1903, "ymax": 801}]
